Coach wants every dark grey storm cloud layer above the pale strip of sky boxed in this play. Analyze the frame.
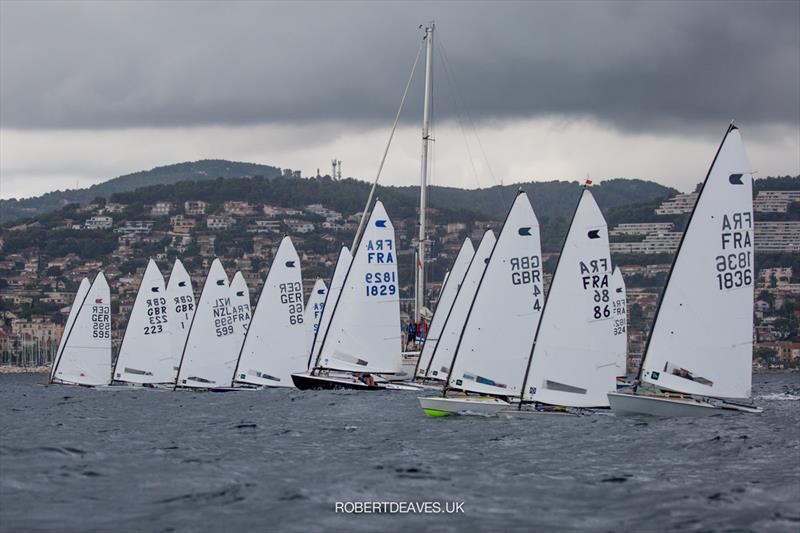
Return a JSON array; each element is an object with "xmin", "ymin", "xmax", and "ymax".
[{"xmin": 0, "ymin": 1, "xmax": 800, "ymax": 131}]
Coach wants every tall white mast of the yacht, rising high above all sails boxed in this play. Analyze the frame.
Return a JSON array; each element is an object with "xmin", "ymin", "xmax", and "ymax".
[{"xmin": 414, "ymin": 22, "xmax": 435, "ymax": 323}]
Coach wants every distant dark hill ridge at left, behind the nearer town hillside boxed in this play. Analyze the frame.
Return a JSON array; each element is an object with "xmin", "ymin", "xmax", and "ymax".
[{"xmin": 0, "ymin": 159, "xmax": 281, "ymax": 223}]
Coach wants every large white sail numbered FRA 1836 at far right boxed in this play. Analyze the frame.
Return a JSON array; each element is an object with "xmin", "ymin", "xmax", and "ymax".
[{"xmin": 641, "ymin": 125, "xmax": 754, "ymax": 398}]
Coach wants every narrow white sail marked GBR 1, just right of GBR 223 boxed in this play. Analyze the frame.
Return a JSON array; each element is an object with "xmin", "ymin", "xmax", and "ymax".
[{"xmin": 167, "ymin": 259, "xmax": 195, "ymax": 382}]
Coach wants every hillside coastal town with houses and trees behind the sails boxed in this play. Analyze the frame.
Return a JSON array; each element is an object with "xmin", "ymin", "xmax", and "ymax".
[{"xmin": 0, "ymin": 179, "xmax": 800, "ymax": 372}]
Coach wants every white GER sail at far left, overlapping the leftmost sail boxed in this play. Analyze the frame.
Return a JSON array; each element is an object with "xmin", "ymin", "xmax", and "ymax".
[{"xmin": 53, "ymin": 272, "xmax": 111, "ymax": 385}]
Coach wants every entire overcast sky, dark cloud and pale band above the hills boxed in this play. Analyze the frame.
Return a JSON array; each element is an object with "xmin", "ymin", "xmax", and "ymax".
[{"xmin": 0, "ymin": 1, "xmax": 800, "ymax": 197}]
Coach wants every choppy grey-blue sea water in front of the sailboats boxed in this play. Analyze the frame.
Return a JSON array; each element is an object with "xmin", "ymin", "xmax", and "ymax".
[{"xmin": 0, "ymin": 374, "xmax": 800, "ymax": 532}]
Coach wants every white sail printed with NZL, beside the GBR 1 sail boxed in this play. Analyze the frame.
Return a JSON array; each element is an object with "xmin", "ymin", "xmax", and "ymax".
[{"xmin": 177, "ymin": 259, "xmax": 241, "ymax": 388}]
